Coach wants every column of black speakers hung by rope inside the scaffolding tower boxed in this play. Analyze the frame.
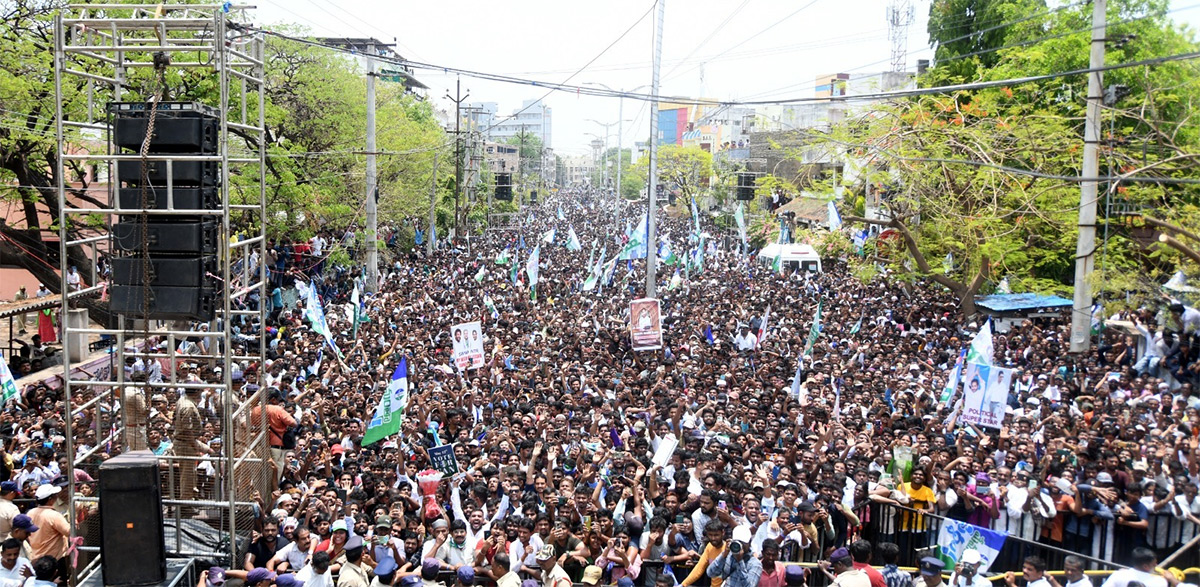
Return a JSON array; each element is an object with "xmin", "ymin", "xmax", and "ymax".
[{"xmin": 109, "ymin": 102, "xmax": 221, "ymax": 322}]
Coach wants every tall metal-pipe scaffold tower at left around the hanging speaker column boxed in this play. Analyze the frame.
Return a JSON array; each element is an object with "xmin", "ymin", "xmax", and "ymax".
[{"xmin": 54, "ymin": 4, "xmax": 270, "ymax": 576}]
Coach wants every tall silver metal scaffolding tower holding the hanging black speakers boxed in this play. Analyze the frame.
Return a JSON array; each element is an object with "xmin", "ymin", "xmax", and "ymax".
[{"xmin": 54, "ymin": 2, "xmax": 274, "ymax": 568}]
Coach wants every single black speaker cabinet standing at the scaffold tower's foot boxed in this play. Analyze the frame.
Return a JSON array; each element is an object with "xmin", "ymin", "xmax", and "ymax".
[{"xmin": 100, "ymin": 450, "xmax": 167, "ymax": 587}]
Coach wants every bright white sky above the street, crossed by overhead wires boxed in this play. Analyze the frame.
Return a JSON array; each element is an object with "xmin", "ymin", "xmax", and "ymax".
[{"xmin": 256, "ymin": 0, "xmax": 1200, "ymax": 155}]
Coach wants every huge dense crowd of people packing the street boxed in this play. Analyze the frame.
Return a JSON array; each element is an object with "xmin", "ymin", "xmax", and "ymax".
[{"xmin": 0, "ymin": 186, "xmax": 1200, "ymax": 587}]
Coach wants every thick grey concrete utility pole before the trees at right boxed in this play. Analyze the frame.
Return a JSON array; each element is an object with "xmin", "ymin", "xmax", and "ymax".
[{"xmin": 1070, "ymin": 0, "xmax": 1108, "ymax": 353}]
